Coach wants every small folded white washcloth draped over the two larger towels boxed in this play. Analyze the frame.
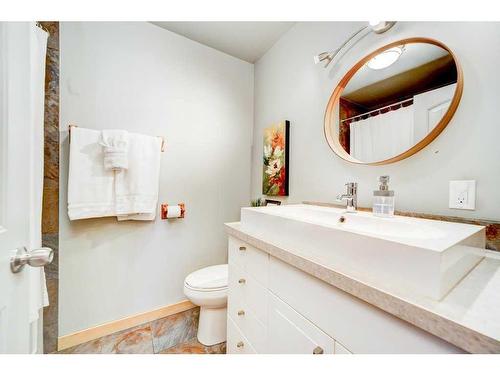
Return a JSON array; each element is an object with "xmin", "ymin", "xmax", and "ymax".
[{"xmin": 100, "ymin": 129, "xmax": 128, "ymax": 171}]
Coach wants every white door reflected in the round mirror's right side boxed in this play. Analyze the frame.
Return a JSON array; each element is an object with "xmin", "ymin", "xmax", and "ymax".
[{"xmin": 413, "ymin": 83, "xmax": 457, "ymax": 143}]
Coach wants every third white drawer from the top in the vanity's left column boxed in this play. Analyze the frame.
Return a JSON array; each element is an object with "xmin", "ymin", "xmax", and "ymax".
[{"xmin": 227, "ymin": 299, "xmax": 267, "ymax": 353}]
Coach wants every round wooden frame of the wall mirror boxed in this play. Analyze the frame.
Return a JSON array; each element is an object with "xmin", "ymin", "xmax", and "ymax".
[{"xmin": 324, "ymin": 37, "xmax": 464, "ymax": 165}]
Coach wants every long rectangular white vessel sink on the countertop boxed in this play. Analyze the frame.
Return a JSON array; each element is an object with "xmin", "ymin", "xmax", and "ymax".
[{"xmin": 241, "ymin": 204, "xmax": 485, "ymax": 300}]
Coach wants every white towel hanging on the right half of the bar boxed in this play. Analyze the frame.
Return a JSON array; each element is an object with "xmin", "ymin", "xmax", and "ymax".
[{"xmin": 115, "ymin": 133, "xmax": 161, "ymax": 221}]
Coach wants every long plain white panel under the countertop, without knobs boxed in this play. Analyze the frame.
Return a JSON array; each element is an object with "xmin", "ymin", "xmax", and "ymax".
[{"xmin": 268, "ymin": 257, "xmax": 463, "ymax": 354}]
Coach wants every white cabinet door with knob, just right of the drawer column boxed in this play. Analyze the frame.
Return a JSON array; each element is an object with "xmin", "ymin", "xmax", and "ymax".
[{"xmin": 267, "ymin": 293, "xmax": 335, "ymax": 354}]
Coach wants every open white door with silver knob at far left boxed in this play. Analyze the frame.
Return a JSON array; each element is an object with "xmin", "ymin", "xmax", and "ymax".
[{"xmin": 0, "ymin": 22, "xmax": 52, "ymax": 353}]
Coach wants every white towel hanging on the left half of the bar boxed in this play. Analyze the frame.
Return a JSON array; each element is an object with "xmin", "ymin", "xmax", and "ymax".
[{"xmin": 68, "ymin": 127, "xmax": 116, "ymax": 220}]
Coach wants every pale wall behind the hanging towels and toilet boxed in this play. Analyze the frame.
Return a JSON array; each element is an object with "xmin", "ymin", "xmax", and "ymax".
[{"xmin": 59, "ymin": 22, "xmax": 253, "ymax": 336}]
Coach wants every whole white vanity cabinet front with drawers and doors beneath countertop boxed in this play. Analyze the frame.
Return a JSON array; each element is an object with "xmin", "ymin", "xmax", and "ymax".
[{"xmin": 227, "ymin": 237, "xmax": 462, "ymax": 354}]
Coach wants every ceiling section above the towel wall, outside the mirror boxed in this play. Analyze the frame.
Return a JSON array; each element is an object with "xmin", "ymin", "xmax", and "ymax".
[{"xmin": 152, "ymin": 22, "xmax": 295, "ymax": 63}]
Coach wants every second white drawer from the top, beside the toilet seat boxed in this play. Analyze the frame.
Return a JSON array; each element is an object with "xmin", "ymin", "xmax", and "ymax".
[{"xmin": 228, "ymin": 264, "xmax": 267, "ymax": 325}]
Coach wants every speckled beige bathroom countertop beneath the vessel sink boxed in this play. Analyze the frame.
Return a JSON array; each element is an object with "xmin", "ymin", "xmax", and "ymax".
[{"xmin": 225, "ymin": 222, "xmax": 500, "ymax": 353}]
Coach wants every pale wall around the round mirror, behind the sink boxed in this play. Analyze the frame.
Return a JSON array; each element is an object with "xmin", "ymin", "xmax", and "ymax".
[{"xmin": 252, "ymin": 22, "xmax": 500, "ymax": 220}]
